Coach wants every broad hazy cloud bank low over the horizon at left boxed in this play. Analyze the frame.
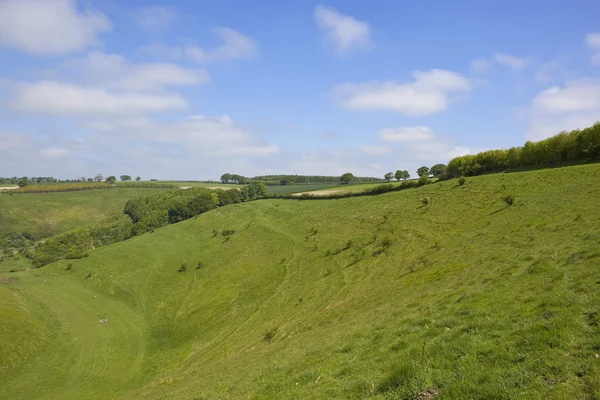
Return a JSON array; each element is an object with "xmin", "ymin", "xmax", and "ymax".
[{"xmin": 0, "ymin": 115, "xmax": 281, "ymax": 179}]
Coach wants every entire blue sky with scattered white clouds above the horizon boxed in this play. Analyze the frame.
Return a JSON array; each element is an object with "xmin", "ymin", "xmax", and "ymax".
[{"xmin": 0, "ymin": 0, "xmax": 600, "ymax": 180}]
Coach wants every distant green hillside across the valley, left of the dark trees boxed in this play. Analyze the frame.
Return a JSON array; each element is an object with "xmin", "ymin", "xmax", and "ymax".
[{"xmin": 0, "ymin": 188, "xmax": 169, "ymax": 235}]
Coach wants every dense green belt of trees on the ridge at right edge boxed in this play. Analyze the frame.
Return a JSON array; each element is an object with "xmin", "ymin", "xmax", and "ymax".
[{"xmin": 440, "ymin": 122, "xmax": 600, "ymax": 179}]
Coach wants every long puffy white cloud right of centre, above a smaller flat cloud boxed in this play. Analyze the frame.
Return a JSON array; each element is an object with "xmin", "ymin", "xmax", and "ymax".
[{"xmin": 332, "ymin": 69, "xmax": 471, "ymax": 116}]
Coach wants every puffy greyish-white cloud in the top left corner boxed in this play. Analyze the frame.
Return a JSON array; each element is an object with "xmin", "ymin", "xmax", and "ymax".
[{"xmin": 0, "ymin": 0, "xmax": 111, "ymax": 55}]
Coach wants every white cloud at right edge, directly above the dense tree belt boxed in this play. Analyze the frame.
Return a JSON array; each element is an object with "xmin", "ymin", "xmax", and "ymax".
[{"xmin": 525, "ymin": 78, "xmax": 600, "ymax": 140}]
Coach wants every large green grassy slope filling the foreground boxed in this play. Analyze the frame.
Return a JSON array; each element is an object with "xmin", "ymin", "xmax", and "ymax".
[{"xmin": 0, "ymin": 164, "xmax": 600, "ymax": 399}]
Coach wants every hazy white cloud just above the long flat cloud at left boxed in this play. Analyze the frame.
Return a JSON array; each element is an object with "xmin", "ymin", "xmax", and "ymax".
[{"xmin": 62, "ymin": 52, "xmax": 210, "ymax": 91}]
